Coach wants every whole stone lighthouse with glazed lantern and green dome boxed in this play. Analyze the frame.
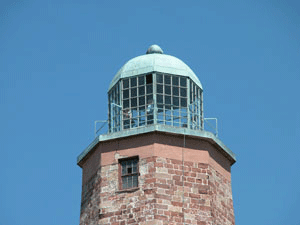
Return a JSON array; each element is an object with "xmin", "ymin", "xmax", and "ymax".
[{"xmin": 77, "ymin": 45, "xmax": 236, "ymax": 225}]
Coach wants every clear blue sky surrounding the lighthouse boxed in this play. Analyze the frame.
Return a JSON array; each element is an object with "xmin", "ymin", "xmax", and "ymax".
[{"xmin": 0, "ymin": 0, "xmax": 300, "ymax": 225}]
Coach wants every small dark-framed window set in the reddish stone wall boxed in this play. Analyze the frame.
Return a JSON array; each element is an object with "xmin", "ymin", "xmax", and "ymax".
[{"xmin": 119, "ymin": 157, "xmax": 139, "ymax": 190}]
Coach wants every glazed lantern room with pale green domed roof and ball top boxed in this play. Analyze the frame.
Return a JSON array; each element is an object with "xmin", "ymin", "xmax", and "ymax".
[{"xmin": 108, "ymin": 45, "xmax": 204, "ymax": 133}]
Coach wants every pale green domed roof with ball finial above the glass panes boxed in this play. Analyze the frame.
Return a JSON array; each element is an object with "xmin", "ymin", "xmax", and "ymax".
[{"xmin": 109, "ymin": 45, "xmax": 202, "ymax": 90}]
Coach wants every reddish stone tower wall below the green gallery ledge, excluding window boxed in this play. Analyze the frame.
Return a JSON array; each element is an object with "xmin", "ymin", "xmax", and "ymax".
[{"xmin": 80, "ymin": 135, "xmax": 234, "ymax": 225}]
